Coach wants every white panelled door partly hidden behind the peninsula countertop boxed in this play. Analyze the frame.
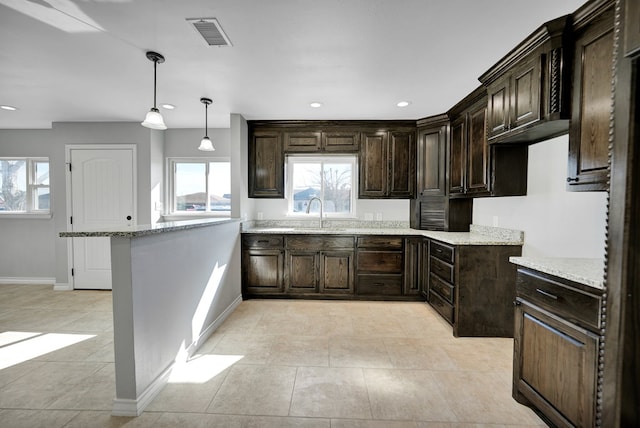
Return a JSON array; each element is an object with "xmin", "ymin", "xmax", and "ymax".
[{"xmin": 69, "ymin": 149, "xmax": 135, "ymax": 290}]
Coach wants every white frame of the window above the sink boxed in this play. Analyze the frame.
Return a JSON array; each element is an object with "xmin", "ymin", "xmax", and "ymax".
[{"xmin": 285, "ymin": 153, "xmax": 358, "ymax": 219}]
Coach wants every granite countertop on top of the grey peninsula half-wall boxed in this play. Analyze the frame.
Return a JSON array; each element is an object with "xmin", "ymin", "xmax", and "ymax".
[{"xmin": 60, "ymin": 217, "xmax": 240, "ymax": 238}]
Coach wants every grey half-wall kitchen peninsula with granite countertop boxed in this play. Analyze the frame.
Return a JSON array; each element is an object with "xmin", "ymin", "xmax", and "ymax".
[{"xmin": 60, "ymin": 219, "xmax": 241, "ymax": 416}]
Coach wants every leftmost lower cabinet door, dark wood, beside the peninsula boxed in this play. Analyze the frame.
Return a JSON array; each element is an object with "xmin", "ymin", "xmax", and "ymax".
[{"xmin": 243, "ymin": 250, "xmax": 284, "ymax": 294}]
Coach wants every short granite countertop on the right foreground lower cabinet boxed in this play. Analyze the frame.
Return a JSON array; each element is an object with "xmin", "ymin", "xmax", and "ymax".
[{"xmin": 509, "ymin": 257, "xmax": 604, "ymax": 289}]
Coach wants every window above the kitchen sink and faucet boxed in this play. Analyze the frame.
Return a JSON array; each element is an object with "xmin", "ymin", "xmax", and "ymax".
[{"xmin": 287, "ymin": 155, "xmax": 357, "ymax": 217}]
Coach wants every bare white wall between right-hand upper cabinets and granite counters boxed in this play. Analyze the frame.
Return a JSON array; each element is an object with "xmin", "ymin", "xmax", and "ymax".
[{"xmin": 473, "ymin": 135, "xmax": 607, "ymax": 258}]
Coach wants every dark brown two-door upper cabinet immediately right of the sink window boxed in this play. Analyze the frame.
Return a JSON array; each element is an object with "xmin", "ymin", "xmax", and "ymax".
[{"xmin": 359, "ymin": 128, "xmax": 416, "ymax": 199}]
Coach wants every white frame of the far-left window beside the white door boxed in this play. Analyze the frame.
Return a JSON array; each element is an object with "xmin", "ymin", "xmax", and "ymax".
[{"xmin": 0, "ymin": 156, "xmax": 53, "ymax": 218}]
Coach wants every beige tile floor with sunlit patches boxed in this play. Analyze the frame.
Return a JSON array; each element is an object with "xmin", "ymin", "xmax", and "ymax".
[{"xmin": 0, "ymin": 285, "xmax": 544, "ymax": 428}]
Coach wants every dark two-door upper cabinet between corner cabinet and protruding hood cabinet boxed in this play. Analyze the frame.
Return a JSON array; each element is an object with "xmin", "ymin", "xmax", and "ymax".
[{"xmin": 448, "ymin": 86, "xmax": 528, "ymax": 198}]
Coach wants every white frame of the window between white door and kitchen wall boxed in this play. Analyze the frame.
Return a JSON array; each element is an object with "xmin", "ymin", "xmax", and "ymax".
[{"xmin": 164, "ymin": 157, "xmax": 233, "ymax": 219}]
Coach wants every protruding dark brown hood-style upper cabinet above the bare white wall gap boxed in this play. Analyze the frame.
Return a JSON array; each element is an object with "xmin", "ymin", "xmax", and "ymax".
[{"xmin": 479, "ymin": 15, "xmax": 570, "ymax": 144}]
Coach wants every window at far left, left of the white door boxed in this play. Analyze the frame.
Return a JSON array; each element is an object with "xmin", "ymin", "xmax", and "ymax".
[{"xmin": 0, "ymin": 158, "xmax": 50, "ymax": 214}]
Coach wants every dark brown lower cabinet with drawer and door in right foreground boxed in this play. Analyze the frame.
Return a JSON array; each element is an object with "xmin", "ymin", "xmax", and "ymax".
[{"xmin": 513, "ymin": 269, "xmax": 600, "ymax": 427}]
